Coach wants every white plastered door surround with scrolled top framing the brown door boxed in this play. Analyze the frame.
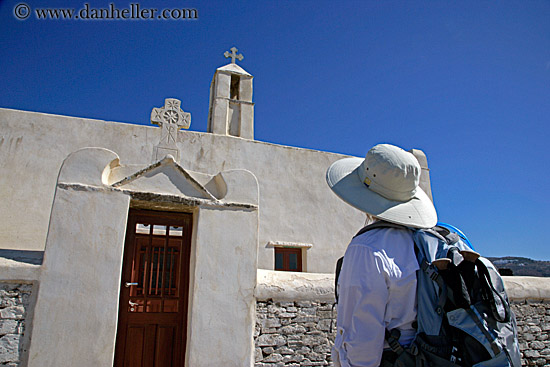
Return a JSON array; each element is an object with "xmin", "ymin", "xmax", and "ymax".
[{"xmin": 22, "ymin": 148, "xmax": 266, "ymax": 367}]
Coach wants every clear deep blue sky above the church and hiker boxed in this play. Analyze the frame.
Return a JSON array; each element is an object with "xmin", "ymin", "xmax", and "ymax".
[{"xmin": 0, "ymin": 0, "xmax": 550, "ymax": 260}]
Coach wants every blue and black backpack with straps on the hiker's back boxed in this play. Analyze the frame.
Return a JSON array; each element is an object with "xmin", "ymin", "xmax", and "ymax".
[{"xmin": 335, "ymin": 221, "xmax": 521, "ymax": 367}]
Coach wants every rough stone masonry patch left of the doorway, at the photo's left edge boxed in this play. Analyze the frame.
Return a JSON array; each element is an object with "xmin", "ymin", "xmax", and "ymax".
[{"xmin": 0, "ymin": 283, "xmax": 32, "ymax": 367}]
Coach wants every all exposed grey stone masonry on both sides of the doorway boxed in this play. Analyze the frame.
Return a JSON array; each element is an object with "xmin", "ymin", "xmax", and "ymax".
[{"xmin": 0, "ymin": 282, "xmax": 550, "ymax": 367}]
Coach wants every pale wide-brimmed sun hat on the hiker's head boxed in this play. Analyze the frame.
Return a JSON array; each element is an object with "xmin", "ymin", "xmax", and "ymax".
[{"xmin": 326, "ymin": 144, "xmax": 437, "ymax": 228}]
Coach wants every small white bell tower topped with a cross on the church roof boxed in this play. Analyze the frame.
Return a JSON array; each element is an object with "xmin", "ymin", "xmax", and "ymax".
[{"xmin": 208, "ymin": 47, "xmax": 254, "ymax": 140}]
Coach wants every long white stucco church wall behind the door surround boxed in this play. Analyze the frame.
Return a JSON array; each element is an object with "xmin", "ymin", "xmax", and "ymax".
[{"xmin": 0, "ymin": 109, "xmax": 364, "ymax": 272}]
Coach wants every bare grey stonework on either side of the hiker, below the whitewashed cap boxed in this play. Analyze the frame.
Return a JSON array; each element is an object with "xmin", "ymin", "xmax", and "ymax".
[{"xmin": 254, "ymin": 300, "xmax": 550, "ymax": 367}]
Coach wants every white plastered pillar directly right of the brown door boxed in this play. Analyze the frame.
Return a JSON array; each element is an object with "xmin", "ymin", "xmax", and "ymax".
[{"xmin": 186, "ymin": 207, "xmax": 258, "ymax": 367}]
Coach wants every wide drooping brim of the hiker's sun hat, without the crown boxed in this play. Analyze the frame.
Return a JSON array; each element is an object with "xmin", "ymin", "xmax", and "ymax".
[{"xmin": 327, "ymin": 158, "xmax": 437, "ymax": 228}]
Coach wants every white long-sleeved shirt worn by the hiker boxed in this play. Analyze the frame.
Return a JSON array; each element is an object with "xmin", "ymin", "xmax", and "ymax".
[{"xmin": 332, "ymin": 228, "xmax": 418, "ymax": 367}]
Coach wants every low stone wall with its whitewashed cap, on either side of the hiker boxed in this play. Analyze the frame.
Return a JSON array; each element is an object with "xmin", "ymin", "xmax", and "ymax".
[{"xmin": 254, "ymin": 270, "xmax": 550, "ymax": 367}]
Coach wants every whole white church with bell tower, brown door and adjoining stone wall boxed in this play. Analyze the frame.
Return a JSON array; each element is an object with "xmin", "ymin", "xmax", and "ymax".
[{"xmin": 0, "ymin": 49, "xmax": 444, "ymax": 367}]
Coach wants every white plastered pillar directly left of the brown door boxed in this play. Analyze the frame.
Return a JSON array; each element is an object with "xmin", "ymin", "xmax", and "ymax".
[{"xmin": 28, "ymin": 183, "xmax": 130, "ymax": 367}]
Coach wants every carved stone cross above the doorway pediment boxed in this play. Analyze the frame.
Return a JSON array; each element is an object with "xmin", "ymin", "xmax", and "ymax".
[{"xmin": 151, "ymin": 98, "xmax": 191, "ymax": 161}]
